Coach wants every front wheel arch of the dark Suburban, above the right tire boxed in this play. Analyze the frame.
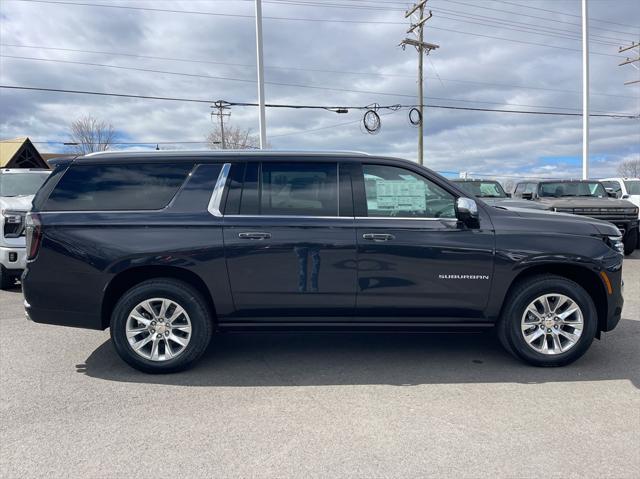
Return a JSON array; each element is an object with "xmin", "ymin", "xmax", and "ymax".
[{"xmin": 499, "ymin": 263, "xmax": 608, "ymax": 337}]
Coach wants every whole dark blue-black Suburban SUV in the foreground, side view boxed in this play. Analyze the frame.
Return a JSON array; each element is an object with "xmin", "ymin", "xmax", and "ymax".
[{"xmin": 23, "ymin": 151, "xmax": 623, "ymax": 372}]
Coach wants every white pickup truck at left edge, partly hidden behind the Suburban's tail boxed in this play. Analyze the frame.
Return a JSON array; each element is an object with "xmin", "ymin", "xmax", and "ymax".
[{"xmin": 0, "ymin": 168, "xmax": 51, "ymax": 289}]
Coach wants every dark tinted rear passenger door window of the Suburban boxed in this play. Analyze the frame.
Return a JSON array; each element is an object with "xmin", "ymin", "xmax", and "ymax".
[{"xmin": 260, "ymin": 162, "xmax": 338, "ymax": 216}]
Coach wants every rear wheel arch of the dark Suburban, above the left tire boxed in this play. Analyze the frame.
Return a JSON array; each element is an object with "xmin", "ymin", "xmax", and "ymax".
[{"xmin": 101, "ymin": 265, "xmax": 216, "ymax": 329}]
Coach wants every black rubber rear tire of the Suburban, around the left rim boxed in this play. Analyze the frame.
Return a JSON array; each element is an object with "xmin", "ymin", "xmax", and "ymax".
[{"xmin": 110, "ymin": 278, "xmax": 213, "ymax": 373}]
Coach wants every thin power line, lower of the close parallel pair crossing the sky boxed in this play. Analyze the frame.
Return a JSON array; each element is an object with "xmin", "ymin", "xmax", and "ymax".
[{"xmin": 6, "ymin": 54, "xmax": 632, "ymax": 112}]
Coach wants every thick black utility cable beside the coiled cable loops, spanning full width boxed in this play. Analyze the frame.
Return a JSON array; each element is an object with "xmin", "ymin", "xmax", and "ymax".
[{"xmin": 0, "ymin": 85, "xmax": 640, "ymax": 119}]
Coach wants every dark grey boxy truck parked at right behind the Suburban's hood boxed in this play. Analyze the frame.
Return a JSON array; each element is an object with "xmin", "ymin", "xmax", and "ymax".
[{"xmin": 513, "ymin": 180, "xmax": 638, "ymax": 254}]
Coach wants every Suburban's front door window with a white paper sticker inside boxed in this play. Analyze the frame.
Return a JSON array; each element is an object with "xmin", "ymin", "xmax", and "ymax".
[{"xmin": 363, "ymin": 165, "xmax": 455, "ymax": 218}]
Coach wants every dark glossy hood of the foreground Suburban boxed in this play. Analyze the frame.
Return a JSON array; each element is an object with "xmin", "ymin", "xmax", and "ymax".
[{"xmin": 492, "ymin": 208, "xmax": 620, "ymax": 236}]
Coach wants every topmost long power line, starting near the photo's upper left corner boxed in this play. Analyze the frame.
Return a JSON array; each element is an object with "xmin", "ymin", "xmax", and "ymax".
[{"xmin": 6, "ymin": 0, "xmax": 618, "ymax": 58}]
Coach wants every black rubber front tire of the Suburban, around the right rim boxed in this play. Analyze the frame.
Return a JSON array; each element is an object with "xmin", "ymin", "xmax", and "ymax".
[{"xmin": 497, "ymin": 274, "xmax": 598, "ymax": 367}]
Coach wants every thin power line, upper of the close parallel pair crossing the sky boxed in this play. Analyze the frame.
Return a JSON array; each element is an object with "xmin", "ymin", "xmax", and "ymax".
[{"xmin": 0, "ymin": 43, "xmax": 636, "ymax": 99}]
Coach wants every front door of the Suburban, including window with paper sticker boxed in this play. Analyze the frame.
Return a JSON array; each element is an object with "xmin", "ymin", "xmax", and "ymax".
[{"xmin": 354, "ymin": 164, "xmax": 494, "ymax": 321}]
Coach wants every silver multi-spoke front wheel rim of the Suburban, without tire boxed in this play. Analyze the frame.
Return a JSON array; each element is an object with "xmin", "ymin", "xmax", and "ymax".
[{"xmin": 520, "ymin": 293, "xmax": 584, "ymax": 355}]
